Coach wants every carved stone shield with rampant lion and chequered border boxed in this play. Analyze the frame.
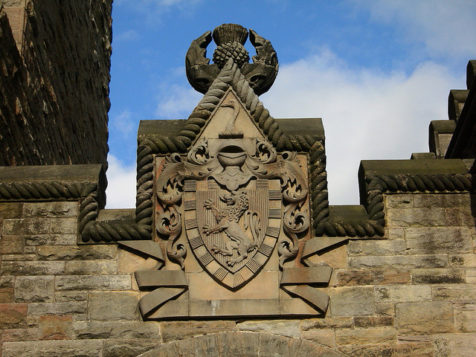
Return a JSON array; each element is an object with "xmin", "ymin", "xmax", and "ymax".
[{"xmin": 184, "ymin": 178, "xmax": 282, "ymax": 289}]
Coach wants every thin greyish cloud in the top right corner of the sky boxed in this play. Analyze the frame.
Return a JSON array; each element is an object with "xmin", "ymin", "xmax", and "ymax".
[{"xmin": 351, "ymin": 0, "xmax": 476, "ymax": 58}]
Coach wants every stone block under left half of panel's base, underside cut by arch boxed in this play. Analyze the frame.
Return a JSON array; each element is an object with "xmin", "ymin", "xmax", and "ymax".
[{"xmin": 160, "ymin": 321, "xmax": 236, "ymax": 342}]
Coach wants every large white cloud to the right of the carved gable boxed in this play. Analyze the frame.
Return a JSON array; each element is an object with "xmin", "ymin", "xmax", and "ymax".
[{"xmin": 261, "ymin": 51, "xmax": 464, "ymax": 204}]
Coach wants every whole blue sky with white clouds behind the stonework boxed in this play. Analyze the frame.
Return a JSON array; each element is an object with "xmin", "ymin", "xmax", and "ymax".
[{"xmin": 107, "ymin": 0, "xmax": 476, "ymax": 208}]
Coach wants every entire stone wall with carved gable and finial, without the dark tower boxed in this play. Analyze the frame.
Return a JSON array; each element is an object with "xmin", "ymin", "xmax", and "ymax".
[{"xmin": 0, "ymin": 15, "xmax": 476, "ymax": 357}]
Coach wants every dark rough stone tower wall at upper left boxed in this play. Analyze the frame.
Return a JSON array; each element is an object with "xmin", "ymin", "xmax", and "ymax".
[{"xmin": 0, "ymin": 0, "xmax": 112, "ymax": 166}]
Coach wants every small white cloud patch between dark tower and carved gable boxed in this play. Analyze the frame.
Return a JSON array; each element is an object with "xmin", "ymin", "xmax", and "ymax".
[{"xmin": 106, "ymin": 154, "xmax": 136, "ymax": 208}]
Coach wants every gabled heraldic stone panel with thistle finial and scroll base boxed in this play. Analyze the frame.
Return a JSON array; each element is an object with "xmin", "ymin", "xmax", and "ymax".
[{"xmin": 122, "ymin": 24, "xmax": 342, "ymax": 320}]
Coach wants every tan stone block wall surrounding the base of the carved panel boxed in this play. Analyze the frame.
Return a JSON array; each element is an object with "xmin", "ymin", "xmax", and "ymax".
[{"xmin": 0, "ymin": 193, "xmax": 476, "ymax": 357}]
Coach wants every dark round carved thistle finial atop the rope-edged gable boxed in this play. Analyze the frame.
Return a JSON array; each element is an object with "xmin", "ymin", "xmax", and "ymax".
[{"xmin": 185, "ymin": 24, "xmax": 278, "ymax": 95}]
